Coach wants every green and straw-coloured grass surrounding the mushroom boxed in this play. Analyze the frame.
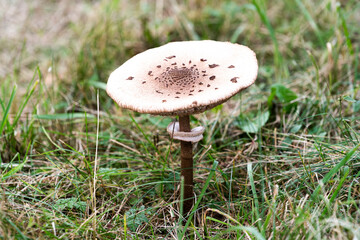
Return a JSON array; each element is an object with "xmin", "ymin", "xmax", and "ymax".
[{"xmin": 0, "ymin": 0, "xmax": 360, "ymax": 239}]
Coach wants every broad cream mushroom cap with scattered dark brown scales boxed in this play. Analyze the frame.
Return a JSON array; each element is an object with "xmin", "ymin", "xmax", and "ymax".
[{"xmin": 106, "ymin": 40, "xmax": 258, "ymax": 116}]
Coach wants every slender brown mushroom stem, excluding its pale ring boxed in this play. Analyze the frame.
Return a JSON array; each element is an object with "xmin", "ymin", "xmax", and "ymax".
[{"xmin": 179, "ymin": 115, "xmax": 194, "ymax": 216}]
